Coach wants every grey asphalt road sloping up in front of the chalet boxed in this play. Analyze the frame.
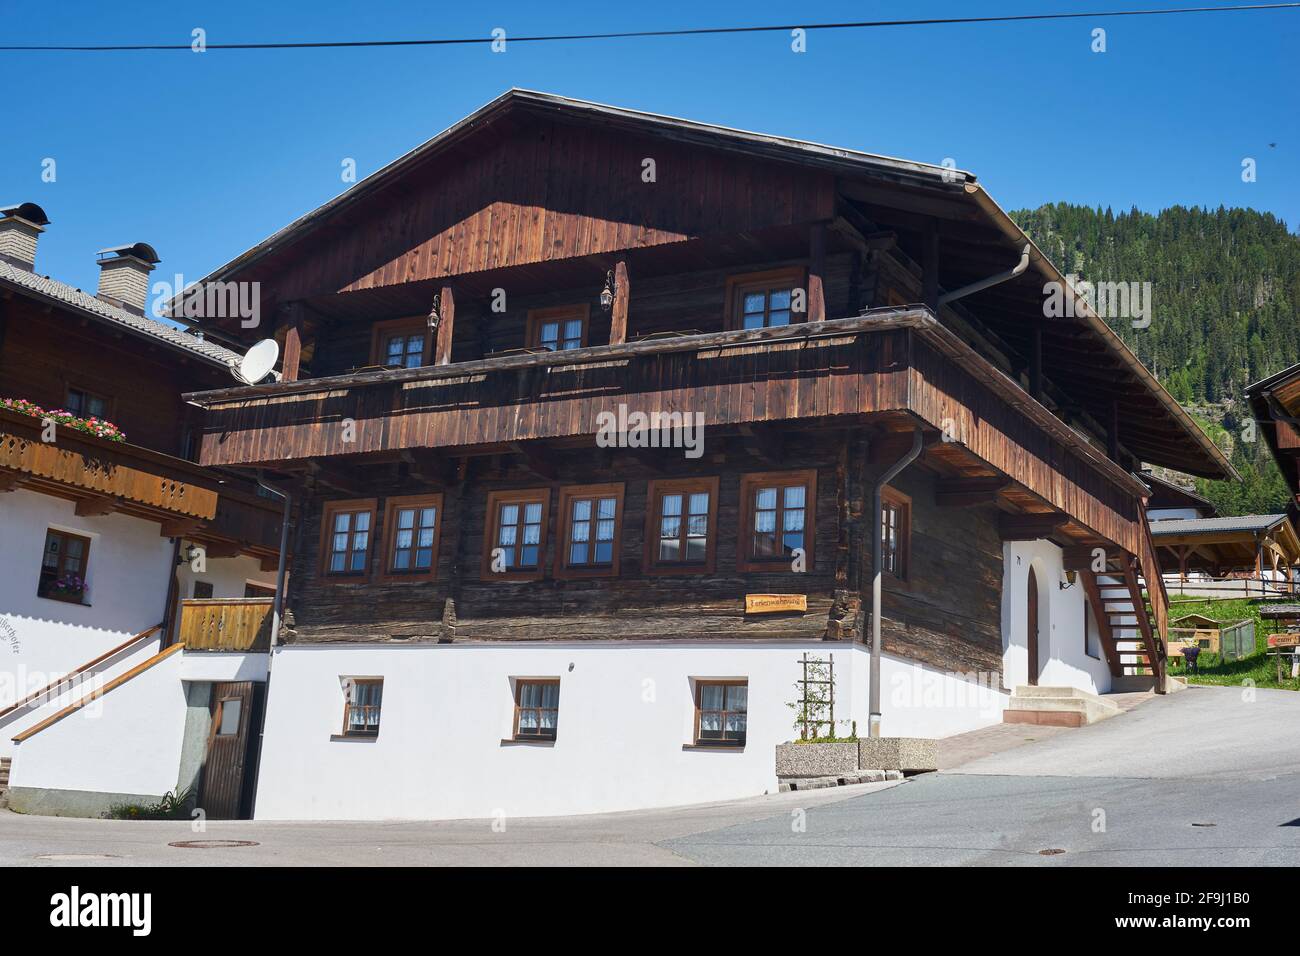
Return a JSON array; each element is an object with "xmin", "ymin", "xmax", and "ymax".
[{"xmin": 0, "ymin": 687, "xmax": 1300, "ymax": 866}]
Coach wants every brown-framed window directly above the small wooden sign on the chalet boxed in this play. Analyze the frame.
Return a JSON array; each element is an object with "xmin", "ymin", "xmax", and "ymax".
[{"xmin": 736, "ymin": 470, "xmax": 816, "ymax": 571}]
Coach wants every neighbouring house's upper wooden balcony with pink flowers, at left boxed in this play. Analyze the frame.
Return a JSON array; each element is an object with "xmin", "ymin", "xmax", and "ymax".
[{"xmin": 0, "ymin": 410, "xmax": 281, "ymax": 568}]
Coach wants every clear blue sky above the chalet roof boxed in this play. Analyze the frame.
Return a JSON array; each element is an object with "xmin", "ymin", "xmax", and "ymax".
[{"xmin": 0, "ymin": 0, "xmax": 1300, "ymax": 303}]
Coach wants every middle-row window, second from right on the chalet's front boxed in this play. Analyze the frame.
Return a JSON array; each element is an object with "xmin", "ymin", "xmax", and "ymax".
[{"xmin": 645, "ymin": 477, "xmax": 718, "ymax": 574}]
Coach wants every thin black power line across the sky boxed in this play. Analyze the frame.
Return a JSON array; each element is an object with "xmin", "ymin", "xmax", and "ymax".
[{"xmin": 0, "ymin": 3, "xmax": 1300, "ymax": 53}]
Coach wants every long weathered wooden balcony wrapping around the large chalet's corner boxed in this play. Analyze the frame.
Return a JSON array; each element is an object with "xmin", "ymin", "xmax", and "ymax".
[{"xmin": 187, "ymin": 307, "xmax": 1145, "ymax": 553}]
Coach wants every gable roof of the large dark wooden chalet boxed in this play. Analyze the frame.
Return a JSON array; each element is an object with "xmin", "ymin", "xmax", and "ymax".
[{"xmin": 180, "ymin": 90, "xmax": 1238, "ymax": 479}]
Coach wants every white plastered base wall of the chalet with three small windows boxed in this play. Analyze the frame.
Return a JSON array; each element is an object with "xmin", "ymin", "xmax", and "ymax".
[{"xmin": 248, "ymin": 643, "xmax": 1005, "ymax": 819}]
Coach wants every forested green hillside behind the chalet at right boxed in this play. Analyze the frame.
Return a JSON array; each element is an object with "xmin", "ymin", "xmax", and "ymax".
[{"xmin": 1011, "ymin": 203, "xmax": 1300, "ymax": 514}]
